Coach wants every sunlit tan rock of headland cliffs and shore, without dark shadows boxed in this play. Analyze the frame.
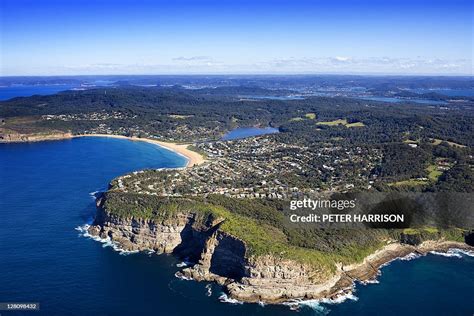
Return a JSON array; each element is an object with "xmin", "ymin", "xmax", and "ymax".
[{"xmin": 86, "ymin": 206, "xmax": 474, "ymax": 305}]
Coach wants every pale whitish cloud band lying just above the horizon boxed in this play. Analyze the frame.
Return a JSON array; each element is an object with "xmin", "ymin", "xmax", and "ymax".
[{"xmin": 2, "ymin": 56, "xmax": 472, "ymax": 75}]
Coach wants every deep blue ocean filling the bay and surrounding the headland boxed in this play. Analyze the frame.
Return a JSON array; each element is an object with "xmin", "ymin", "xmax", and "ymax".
[{"xmin": 0, "ymin": 137, "xmax": 474, "ymax": 316}]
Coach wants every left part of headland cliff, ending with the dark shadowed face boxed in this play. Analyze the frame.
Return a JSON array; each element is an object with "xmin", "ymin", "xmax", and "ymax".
[{"xmin": 89, "ymin": 205, "xmax": 247, "ymax": 274}]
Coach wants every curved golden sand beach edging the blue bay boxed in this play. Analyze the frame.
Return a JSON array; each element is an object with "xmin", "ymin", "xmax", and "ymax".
[{"xmin": 73, "ymin": 134, "xmax": 205, "ymax": 167}]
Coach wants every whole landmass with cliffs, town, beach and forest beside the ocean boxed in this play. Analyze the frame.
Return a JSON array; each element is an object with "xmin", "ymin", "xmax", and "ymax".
[{"xmin": 0, "ymin": 83, "xmax": 474, "ymax": 303}]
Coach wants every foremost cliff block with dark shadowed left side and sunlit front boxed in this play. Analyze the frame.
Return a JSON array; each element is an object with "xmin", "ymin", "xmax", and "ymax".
[{"xmin": 178, "ymin": 231, "xmax": 339, "ymax": 303}]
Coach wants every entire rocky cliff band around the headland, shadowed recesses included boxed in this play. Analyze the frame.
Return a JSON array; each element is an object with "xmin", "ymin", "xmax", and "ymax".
[{"xmin": 89, "ymin": 200, "xmax": 469, "ymax": 303}]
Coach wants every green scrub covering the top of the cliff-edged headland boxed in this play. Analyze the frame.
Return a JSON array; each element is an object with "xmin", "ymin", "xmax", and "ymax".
[{"xmin": 104, "ymin": 191, "xmax": 465, "ymax": 271}]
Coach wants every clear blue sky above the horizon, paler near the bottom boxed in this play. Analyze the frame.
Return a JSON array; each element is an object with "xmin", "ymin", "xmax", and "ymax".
[{"xmin": 0, "ymin": 0, "xmax": 473, "ymax": 75}]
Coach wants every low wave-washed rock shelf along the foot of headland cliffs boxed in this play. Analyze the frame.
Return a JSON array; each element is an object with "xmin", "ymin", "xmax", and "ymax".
[{"xmin": 84, "ymin": 210, "xmax": 474, "ymax": 309}]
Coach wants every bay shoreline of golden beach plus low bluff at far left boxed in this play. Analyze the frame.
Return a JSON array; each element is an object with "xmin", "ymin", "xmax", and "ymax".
[{"xmin": 0, "ymin": 132, "xmax": 206, "ymax": 168}]
